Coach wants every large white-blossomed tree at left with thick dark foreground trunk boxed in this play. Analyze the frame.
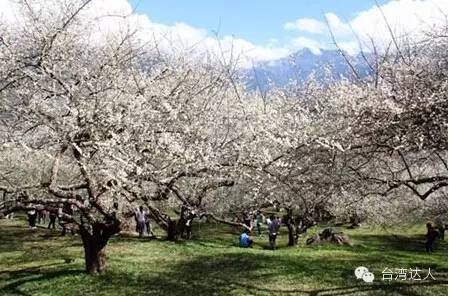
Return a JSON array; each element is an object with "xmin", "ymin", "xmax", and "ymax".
[{"xmin": 0, "ymin": 0, "xmax": 260, "ymax": 274}]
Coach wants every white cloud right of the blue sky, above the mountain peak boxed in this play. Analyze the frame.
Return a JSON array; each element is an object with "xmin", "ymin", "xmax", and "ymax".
[{"xmin": 284, "ymin": 0, "xmax": 448, "ymax": 53}]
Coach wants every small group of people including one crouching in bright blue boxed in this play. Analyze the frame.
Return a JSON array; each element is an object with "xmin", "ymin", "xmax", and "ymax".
[{"xmin": 239, "ymin": 212, "xmax": 282, "ymax": 250}]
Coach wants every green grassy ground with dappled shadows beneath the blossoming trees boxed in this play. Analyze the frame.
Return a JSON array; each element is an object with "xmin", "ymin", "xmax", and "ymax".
[{"xmin": 0, "ymin": 219, "xmax": 447, "ymax": 296}]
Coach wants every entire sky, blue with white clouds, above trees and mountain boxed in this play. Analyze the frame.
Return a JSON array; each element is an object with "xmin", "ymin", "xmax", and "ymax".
[{"xmin": 0, "ymin": 0, "xmax": 448, "ymax": 66}]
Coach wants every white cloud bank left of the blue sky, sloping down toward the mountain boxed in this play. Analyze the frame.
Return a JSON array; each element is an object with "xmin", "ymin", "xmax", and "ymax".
[{"xmin": 0, "ymin": 0, "xmax": 290, "ymax": 66}]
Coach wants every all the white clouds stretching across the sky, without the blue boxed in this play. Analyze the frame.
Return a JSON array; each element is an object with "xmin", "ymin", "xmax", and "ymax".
[{"xmin": 0, "ymin": 0, "xmax": 447, "ymax": 66}]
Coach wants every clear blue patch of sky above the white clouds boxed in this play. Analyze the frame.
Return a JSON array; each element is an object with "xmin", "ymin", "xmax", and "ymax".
[{"xmin": 130, "ymin": 0, "xmax": 388, "ymax": 44}]
